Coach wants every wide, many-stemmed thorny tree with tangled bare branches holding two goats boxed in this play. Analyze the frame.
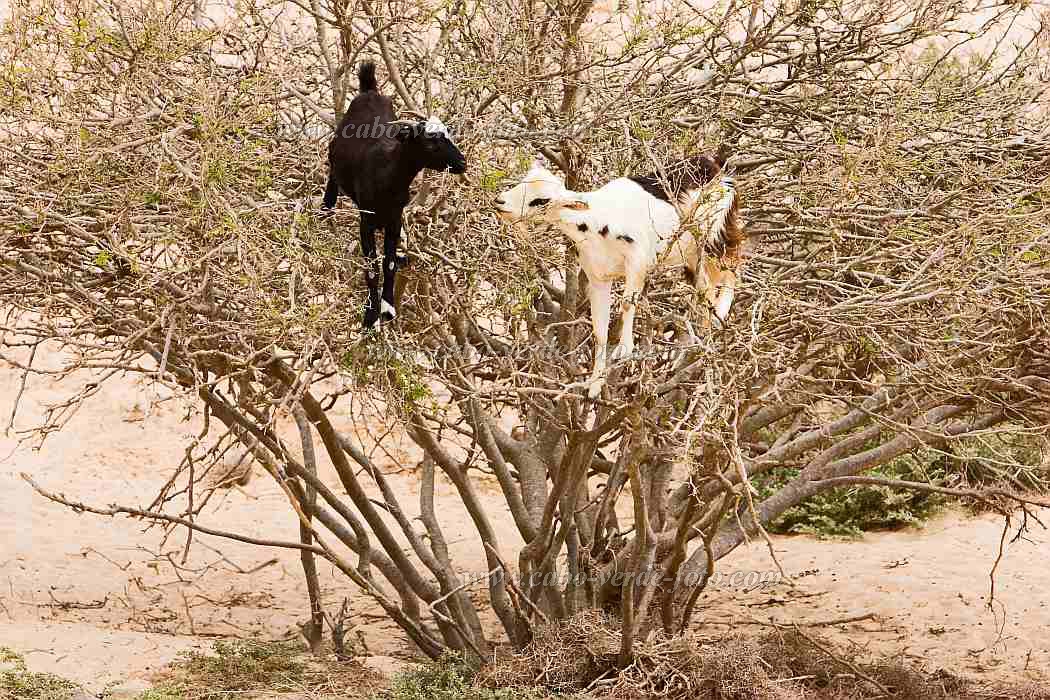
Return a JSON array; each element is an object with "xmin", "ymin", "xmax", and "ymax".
[{"xmin": 0, "ymin": 0, "xmax": 1050, "ymax": 660}]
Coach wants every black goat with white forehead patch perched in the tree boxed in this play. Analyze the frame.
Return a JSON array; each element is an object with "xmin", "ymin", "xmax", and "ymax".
[{"xmin": 323, "ymin": 61, "xmax": 466, "ymax": 327}]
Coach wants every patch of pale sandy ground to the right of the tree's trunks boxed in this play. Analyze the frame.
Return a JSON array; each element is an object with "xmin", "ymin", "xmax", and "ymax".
[{"xmin": 698, "ymin": 512, "xmax": 1050, "ymax": 680}]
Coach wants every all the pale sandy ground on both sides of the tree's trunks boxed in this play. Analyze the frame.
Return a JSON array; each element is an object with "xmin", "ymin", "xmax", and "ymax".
[{"xmin": 0, "ymin": 342, "xmax": 1050, "ymax": 692}]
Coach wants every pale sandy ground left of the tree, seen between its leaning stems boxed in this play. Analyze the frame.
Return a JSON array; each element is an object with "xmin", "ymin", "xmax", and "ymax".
[{"xmin": 0, "ymin": 340, "xmax": 521, "ymax": 690}]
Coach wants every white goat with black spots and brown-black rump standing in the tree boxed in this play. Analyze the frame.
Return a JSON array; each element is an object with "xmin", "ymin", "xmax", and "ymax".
[{"xmin": 495, "ymin": 156, "xmax": 744, "ymax": 399}]
